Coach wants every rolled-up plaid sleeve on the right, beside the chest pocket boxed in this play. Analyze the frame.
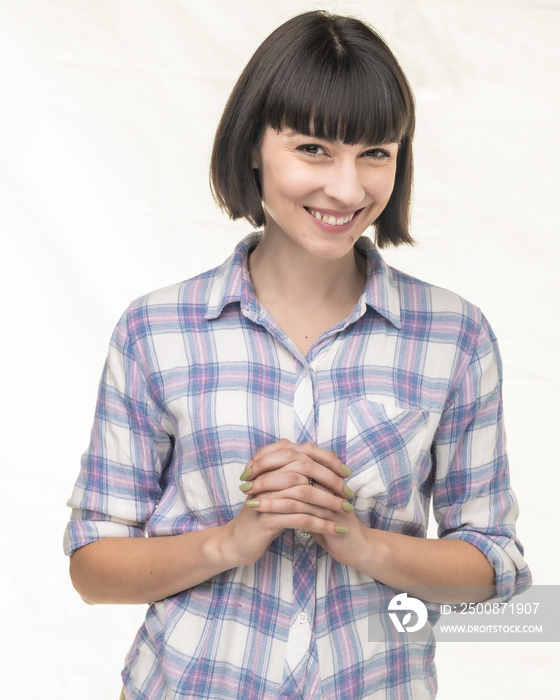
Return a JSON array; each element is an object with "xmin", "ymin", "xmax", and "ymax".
[{"xmin": 433, "ymin": 317, "xmax": 531, "ymax": 600}]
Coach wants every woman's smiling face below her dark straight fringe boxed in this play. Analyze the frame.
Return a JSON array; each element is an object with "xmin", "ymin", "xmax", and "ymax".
[{"xmin": 253, "ymin": 127, "xmax": 398, "ymax": 259}]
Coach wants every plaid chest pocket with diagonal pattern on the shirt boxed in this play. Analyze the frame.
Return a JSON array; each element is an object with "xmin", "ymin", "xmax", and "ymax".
[{"xmin": 346, "ymin": 399, "xmax": 432, "ymax": 509}]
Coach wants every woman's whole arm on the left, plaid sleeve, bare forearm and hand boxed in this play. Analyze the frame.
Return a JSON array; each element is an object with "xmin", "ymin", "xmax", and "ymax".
[{"xmin": 65, "ymin": 301, "xmax": 354, "ymax": 603}]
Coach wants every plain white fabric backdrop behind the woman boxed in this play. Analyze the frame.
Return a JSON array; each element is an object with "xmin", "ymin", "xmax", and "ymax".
[{"xmin": 0, "ymin": 0, "xmax": 560, "ymax": 700}]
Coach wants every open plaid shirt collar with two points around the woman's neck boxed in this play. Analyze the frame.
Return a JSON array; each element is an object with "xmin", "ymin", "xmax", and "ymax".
[{"xmin": 205, "ymin": 233, "xmax": 401, "ymax": 328}]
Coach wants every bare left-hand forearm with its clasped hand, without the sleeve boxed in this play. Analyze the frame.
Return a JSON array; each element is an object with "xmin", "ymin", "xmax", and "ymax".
[{"xmin": 70, "ymin": 440, "xmax": 346, "ymax": 604}]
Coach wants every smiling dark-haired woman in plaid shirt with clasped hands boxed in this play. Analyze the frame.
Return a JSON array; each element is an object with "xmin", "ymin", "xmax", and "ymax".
[{"xmin": 65, "ymin": 12, "xmax": 530, "ymax": 700}]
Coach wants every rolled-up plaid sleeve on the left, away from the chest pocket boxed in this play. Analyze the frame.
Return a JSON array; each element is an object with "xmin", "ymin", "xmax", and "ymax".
[{"xmin": 64, "ymin": 304, "xmax": 171, "ymax": 555}]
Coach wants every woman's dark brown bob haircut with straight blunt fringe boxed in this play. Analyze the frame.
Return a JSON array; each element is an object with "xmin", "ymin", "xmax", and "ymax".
[{"xmin": 210, "ymin": 11, "xmax": 415, "ymax": 247}]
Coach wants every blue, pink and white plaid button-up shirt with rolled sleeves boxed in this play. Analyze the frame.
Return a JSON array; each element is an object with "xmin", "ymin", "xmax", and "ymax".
[{"xmin": 65, "ymin": 236, "xmax": 530, "ymax": 700}]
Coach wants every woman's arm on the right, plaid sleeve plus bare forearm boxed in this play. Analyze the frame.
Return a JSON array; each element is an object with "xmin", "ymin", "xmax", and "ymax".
[{"xmin": 302, "ymin": 319, "xmax": 530, "ymax": 602}]
